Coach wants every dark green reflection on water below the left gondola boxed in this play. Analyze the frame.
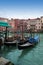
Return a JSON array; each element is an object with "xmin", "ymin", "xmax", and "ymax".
[{"xmin": 0, "ymin": 46, "xmax": 16, "ymax": 57}]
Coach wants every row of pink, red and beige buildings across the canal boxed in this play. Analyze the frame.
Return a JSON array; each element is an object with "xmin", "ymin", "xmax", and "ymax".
[{"xmin": 0, "ymin": 16, "xmax": 43, "ymax": 32}]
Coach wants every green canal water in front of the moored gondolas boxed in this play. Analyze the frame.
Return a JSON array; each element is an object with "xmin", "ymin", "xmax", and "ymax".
[{"xmin": 0, "ymin": 34, "xmax": 43, "ymax": 65}]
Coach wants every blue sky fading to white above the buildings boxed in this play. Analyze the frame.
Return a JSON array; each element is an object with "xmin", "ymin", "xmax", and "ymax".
[{"xmin": 0, "ymin": 0, "xmax": 43, "ymax": 19}]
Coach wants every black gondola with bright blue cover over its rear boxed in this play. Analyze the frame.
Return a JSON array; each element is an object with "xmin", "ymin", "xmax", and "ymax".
[{"xmin": 18, "ymin": 36, "xmax": 39, "ymax": 49}]
